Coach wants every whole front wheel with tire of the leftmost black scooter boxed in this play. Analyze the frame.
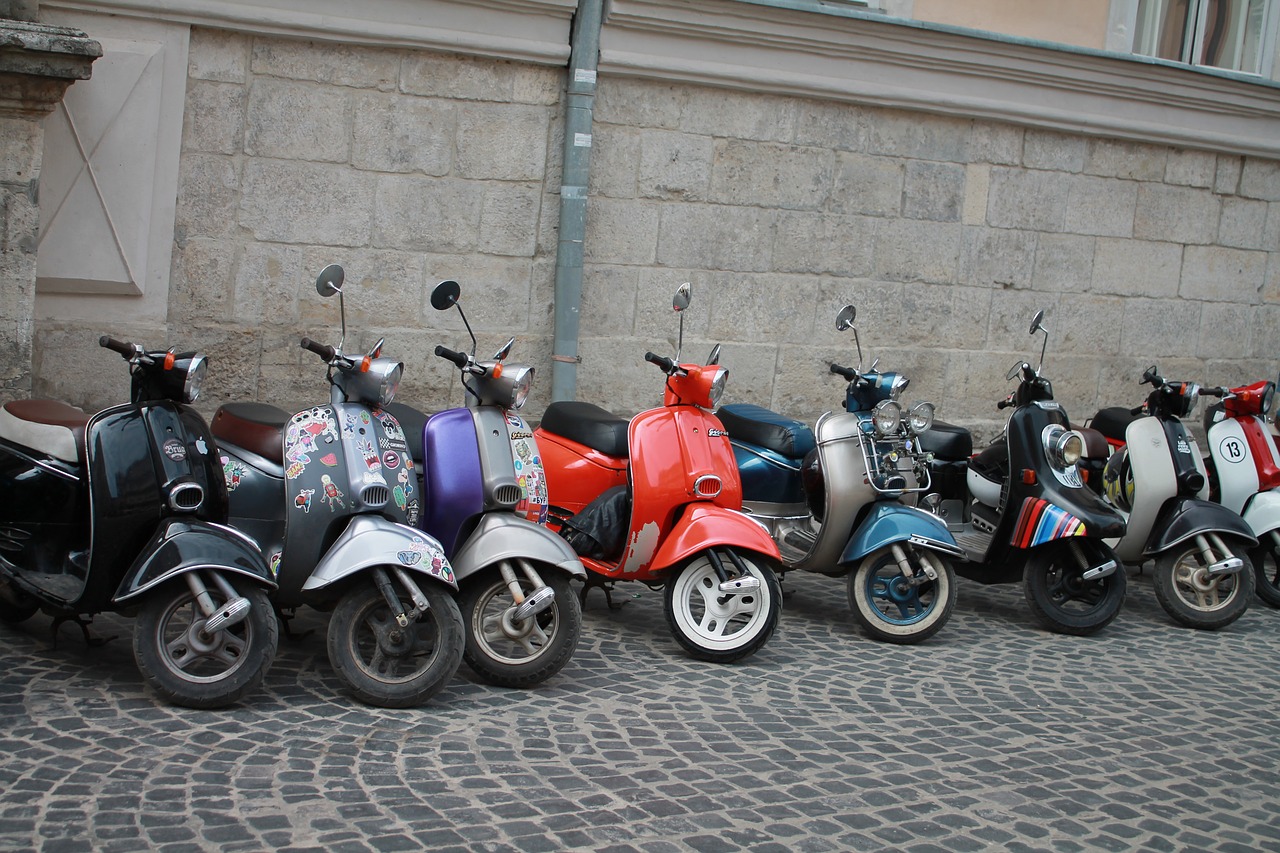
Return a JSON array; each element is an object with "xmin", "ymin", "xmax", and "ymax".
[{"xmin": 133, "ymin": 579, "xmax": 280, "ymax": 710}]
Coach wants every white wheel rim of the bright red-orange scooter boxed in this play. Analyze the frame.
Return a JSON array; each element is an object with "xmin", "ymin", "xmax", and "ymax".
[{"xmin": 671, "ymin": 557, "xmax": 769, "ymax": 651}]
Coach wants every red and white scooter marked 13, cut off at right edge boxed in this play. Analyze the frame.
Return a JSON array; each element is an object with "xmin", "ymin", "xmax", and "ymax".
[{"xmin": 1204, "ymin": 382, "xmax": 1280, "ymax": 607}]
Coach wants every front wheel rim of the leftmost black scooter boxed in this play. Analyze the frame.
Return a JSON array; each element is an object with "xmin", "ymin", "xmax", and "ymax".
[{"xmin": 155, "ymin": 592, "xmax": 253, "ymax": 684}]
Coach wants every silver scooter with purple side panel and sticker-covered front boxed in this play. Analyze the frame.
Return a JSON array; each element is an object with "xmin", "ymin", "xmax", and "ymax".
[{"xmin": 378, "ymin": 280, "xmax": 586, "ymax": 686}]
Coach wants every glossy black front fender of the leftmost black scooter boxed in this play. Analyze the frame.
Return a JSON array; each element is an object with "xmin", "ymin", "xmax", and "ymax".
[{"xmin": 113, "ymin": 517, "xmax": 275, "ymax": 603}]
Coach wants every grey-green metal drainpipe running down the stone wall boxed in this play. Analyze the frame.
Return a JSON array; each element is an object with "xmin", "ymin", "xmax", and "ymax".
[{"xmin": 552, "ymin": 0, "xmax": 604, "ymax": 401}]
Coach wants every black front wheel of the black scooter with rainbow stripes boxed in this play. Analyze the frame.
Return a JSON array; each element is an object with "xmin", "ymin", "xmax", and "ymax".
[{"xmin": 1023, "ymin": 539, "xmax": 1128, "ymax": 637}]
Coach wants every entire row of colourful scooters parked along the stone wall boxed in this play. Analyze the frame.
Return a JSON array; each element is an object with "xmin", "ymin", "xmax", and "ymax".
[{"xmin": 0, "ymin": 265, "xmax": 1280, "ymax": 708}]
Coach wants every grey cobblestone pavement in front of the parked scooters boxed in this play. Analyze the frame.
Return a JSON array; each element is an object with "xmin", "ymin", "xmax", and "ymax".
[{"xmin": 0, "ymin": 563, "xmax": 1280, "ymax": 852}]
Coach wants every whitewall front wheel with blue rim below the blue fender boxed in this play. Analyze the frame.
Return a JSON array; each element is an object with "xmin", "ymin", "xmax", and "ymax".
[{"xmin": 849, "ymin": 543, "xmax": 956, "ymax": 646}]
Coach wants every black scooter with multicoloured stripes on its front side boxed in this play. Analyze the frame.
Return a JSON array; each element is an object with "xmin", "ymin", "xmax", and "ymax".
[{"xmin": 920, "ymin": 311, "xmax": 1125, "ymax": 635}]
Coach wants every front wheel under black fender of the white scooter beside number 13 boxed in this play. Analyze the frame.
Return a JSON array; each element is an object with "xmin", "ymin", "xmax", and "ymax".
[{"xmin": 1153, "ymin": 540, "xmax": 1256, "ymax": 630}]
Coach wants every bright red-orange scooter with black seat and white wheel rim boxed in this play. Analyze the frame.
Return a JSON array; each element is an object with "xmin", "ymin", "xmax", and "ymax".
[{"xmin": 534, "ymin": 283, "xmax": 782, "ymax": 662}]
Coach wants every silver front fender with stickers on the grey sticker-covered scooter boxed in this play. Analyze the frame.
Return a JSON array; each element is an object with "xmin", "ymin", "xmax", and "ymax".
[{"xmin": 302, "ymin": 515, "xmax": 458, "ymax": 592}]
